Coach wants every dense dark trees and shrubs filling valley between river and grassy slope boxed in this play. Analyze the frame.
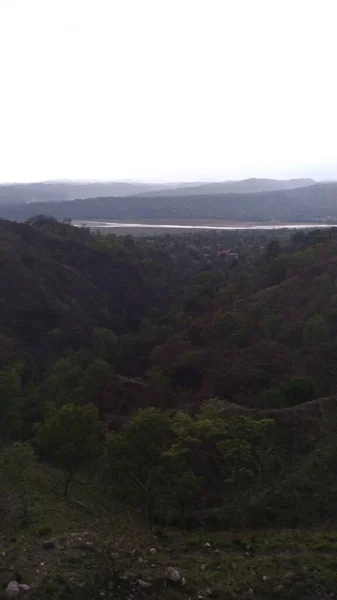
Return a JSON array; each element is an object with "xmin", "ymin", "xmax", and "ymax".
[{"xmin": 0, "ymin": 217, "xmax": 337, "ymax": 598}]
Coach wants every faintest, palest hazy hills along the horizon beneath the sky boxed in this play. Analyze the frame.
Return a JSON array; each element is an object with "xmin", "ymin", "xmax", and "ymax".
[{"xmin": 0, "ymin": 179, "xmax": 315, "ymax": 204}]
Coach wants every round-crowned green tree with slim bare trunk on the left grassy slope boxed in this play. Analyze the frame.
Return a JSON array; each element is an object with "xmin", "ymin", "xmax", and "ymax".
[{"xmin": 35, "ymin": 404, "xmax": 103, "ymax": 496}]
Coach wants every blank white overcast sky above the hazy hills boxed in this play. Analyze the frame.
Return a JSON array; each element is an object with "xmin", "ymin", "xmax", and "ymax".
[{"xmin": 0, "ymin": 0, "xmax": 337, "ymax": 182}]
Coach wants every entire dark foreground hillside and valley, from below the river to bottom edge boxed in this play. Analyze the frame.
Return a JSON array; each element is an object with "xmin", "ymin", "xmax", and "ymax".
[{"xmin": 0, "ymin": 216, "xmax": 337, "ymax": 600}]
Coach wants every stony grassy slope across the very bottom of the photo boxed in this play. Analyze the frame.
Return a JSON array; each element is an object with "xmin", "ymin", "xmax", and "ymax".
[{"xmin": 0, "ymin": 466, "xmax": 337, "ymax": 600}]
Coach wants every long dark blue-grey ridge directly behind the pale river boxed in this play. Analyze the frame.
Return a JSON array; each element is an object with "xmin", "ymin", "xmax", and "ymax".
[{"xmin": 0, "ymin": 182, "xmax": 337, "ymax": 224}]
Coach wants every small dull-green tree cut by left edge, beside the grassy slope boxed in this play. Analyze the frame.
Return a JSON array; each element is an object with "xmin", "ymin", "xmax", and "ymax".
[{"xmin": 0, "ymin": 442, "xmax": 35, "ymax": 516}]
